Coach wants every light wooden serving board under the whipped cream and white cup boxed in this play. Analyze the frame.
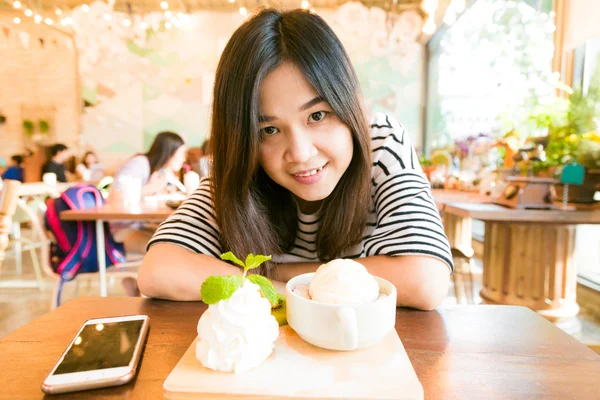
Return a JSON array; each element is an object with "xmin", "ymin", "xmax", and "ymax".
[{"xmin": 163, "ymin": 326, "xmax": 423, "ymax": 400}]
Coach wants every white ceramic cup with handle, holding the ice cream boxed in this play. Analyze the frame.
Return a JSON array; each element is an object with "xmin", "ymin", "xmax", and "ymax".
[{"xmin": 285, "ymin": 273, "xmax": 396, "ymax": 350}]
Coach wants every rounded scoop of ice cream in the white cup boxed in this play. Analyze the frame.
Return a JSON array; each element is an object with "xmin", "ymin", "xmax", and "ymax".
[{"xmin": 308, "ymin": 259, "xmax": 379, "ymax": 304}]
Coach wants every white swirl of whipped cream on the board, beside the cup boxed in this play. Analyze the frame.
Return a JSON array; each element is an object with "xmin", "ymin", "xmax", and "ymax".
[{"xmin": 196, "ymin": 281, "xmax": 279, "ymax": 373}]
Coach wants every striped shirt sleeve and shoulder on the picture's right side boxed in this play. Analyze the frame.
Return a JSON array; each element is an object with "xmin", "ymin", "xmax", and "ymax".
[{"xmin": 365, "ymin": 114, "xmax": 454, "ymax": 271}]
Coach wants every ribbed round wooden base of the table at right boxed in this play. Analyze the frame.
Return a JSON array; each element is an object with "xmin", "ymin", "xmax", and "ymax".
[{"xmin": 481, "ymin": 221, "xmax": 579, "ymax": 322}]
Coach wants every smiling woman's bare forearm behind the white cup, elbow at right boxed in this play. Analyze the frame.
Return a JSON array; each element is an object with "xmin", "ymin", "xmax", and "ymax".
[{"xmin": 274, "ymin": 255, "xmax": 450, "ymax": 310}]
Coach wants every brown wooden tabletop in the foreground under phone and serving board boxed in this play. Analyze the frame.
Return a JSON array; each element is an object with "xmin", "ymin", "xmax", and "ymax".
[{"xmin": 0, "ymin": 297, "xmax": 600, "ymax": 400}]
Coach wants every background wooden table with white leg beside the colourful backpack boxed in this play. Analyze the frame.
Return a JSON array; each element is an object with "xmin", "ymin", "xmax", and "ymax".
[{"xmin": 60, "ymin": 203, "xmax": 173, "ymax": 297}]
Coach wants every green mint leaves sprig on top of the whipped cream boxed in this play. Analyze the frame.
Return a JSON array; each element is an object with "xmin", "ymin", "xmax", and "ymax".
[{"xmin": 200, "ymin": 252, "xmax": 278, "ymax": 305}]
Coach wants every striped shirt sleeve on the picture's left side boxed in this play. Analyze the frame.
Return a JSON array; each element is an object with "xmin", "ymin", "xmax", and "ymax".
[{"xmin": 148, "ymin": 178, "xmax": 221, "ymax": 258}]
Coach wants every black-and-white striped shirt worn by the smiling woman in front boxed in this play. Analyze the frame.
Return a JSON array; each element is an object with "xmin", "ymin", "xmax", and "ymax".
[{"xmin": 148, "ymin": 113, "xmax": 453, "ymax": 271}]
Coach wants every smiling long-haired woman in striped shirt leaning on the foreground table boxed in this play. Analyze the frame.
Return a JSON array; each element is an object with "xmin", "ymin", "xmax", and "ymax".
[{"xmin": 139, "ymin": 10, "xmax": 452, "ymax": 310}]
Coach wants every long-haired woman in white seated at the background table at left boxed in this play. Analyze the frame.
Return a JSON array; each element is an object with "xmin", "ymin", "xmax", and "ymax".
[{"xmin": 108, "ymin": 132, "xmax": 186, "ymax": 254}]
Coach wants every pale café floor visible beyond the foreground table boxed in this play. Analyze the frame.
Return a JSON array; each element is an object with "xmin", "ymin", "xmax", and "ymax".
[{"xmin": 0, "ymin": 247, "xmax": 600, "ymax": 354}]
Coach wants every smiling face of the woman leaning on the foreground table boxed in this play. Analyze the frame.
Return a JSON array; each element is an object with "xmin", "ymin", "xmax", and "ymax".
[{"xmin": 260, "ymin": 63, "xmax": 353, "ymax": 212}]
